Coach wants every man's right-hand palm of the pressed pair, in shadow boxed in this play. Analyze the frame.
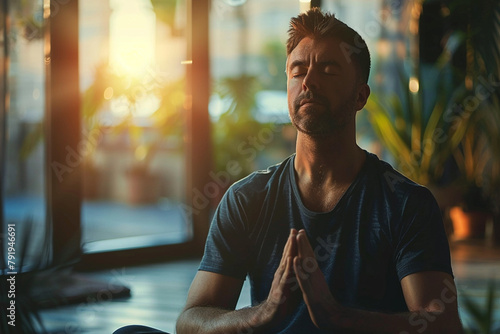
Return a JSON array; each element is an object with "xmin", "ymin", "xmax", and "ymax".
[{"xmin": 293, "ymin": 230, "xmax": 340, "ymax": 329}]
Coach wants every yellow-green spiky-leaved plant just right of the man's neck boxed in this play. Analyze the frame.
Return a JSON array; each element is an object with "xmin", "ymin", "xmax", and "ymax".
[{"xmin": 365, "ymin": 69, "xmax": 468, "ymax": 187}]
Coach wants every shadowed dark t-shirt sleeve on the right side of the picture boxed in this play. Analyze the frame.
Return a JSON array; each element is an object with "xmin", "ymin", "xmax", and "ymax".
[{"xmin": 395, "ymin": 187, "xmax": 453, "ymax": 280}]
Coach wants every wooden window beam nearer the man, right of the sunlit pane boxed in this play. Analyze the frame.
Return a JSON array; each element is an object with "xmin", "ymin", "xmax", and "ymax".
[{"xmin": 186, "ymin": 0, "xmax": 212, "ymax": 252}]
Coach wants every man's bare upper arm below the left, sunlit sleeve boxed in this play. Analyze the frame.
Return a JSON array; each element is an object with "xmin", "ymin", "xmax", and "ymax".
[{"xmin": 185, "ymin": 270, "xmax": 243, "ymax": 310}]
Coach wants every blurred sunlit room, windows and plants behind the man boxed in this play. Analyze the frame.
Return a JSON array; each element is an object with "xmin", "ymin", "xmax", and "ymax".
[{"xmin": 0, "ymin": 0, "xmax": 500, "ymax": 333}]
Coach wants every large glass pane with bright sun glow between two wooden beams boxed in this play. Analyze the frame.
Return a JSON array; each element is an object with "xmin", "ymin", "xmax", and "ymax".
[{"xmin": 80, "ymin": 0, "xmax": 192, "ymax": 251}]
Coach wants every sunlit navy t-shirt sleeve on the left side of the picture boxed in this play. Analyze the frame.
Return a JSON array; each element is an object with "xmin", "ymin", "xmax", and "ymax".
[{"xmin": 198, "ymin": 187, "xmax": 250, "ymax": 279}]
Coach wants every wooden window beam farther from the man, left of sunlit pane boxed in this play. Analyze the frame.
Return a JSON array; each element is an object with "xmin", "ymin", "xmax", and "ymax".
[{"xmin": 45, "ymin": 0, "xmax": 82, "ymax": 264}]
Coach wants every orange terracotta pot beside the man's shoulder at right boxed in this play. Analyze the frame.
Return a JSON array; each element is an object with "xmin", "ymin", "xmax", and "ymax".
[{"xmin": 450, "ymin": 206, "xmax": 491, "ymax": 240}]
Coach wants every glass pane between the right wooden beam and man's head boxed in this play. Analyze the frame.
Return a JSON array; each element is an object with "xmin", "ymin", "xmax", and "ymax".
[{"xmin": 209, "ymin": 0, "xmax": 300, "ymax": 185}]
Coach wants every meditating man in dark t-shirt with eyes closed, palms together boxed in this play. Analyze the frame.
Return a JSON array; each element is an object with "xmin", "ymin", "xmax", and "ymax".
[{"xmin": 177, "ymin": 9, "xmax": 462, "ymax": 334}]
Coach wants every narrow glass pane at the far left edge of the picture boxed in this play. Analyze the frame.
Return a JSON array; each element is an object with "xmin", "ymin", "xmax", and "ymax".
[{"xmin": 0, "ymin": 1, "xmax": 48, "ymax": 265}]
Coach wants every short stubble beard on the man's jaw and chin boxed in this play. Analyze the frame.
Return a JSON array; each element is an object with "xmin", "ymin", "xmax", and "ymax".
[{"xmin": 290, "ymin": 91, "xmax": 356, "ymax": 137}]
